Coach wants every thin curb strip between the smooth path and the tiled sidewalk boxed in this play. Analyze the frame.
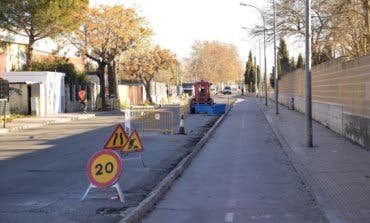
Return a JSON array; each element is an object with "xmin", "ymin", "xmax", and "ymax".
[{"xmin": 256, "ymin": 102, "xmax": 345, "ymax": 223}]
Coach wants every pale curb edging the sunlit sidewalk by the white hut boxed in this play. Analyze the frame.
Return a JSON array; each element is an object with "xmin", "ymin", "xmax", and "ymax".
[{"xmin": 0, "ymin": 114, "xmax": 95, "ymax": 134}]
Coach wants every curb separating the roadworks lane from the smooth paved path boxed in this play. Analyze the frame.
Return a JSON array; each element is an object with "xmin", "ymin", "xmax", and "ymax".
[{"xmin": 119, "ymin": 103, "xmax": 233, "ymax": 223}]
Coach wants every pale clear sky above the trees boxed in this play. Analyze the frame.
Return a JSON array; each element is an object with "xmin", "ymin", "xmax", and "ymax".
[{"xmin": 90, "ymin": 0, "xmax": 303, "ymax": 70}]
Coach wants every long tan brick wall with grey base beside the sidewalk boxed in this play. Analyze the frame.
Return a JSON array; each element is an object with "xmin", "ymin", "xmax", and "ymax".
[{"xmin": 279, "ymin": 55, "xmax": 370, "ymax": 148}]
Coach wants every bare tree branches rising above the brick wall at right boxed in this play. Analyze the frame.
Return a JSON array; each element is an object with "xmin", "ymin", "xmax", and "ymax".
[{"xmin": 251, "ymin": 0, "xmax": 370, "ymax": 64}]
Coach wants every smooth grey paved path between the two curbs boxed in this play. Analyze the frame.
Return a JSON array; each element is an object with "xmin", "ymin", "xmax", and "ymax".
[{"xmin": 142, "ymin": 99, "xmax": 325, "ymax": 223}]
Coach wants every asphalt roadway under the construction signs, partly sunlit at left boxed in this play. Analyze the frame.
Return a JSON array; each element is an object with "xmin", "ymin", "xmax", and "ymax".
[{"xmin": 0, "ymin": 107, "xmax": 218, "ymax": 223}]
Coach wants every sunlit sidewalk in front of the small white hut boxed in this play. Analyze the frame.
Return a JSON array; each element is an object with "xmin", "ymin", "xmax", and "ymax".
[{"xmin": 0, "ymin": 113, "xmax": 95, "ymax": 134}]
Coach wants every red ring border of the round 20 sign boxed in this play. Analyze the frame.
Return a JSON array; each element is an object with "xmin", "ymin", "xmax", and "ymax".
[{"xmin": 87, "ymin": 150, "xmax": 122, "ymax": 188}]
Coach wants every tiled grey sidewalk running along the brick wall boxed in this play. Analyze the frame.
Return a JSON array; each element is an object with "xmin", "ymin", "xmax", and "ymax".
[{"xmin": 256, "ymin": 99, "xmax": 370, "ymax": 222}]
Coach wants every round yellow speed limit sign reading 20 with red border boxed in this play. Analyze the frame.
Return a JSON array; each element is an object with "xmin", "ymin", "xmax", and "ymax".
[{"xmin": 87, "ymin": 150, "xmax": 122, "ymax": 187}]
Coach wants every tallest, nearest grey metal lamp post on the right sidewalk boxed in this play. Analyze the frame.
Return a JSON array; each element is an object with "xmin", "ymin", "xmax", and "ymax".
[{"xmin": 305, "ymin": 0, "xmax": 313, "ymax": 147}]
